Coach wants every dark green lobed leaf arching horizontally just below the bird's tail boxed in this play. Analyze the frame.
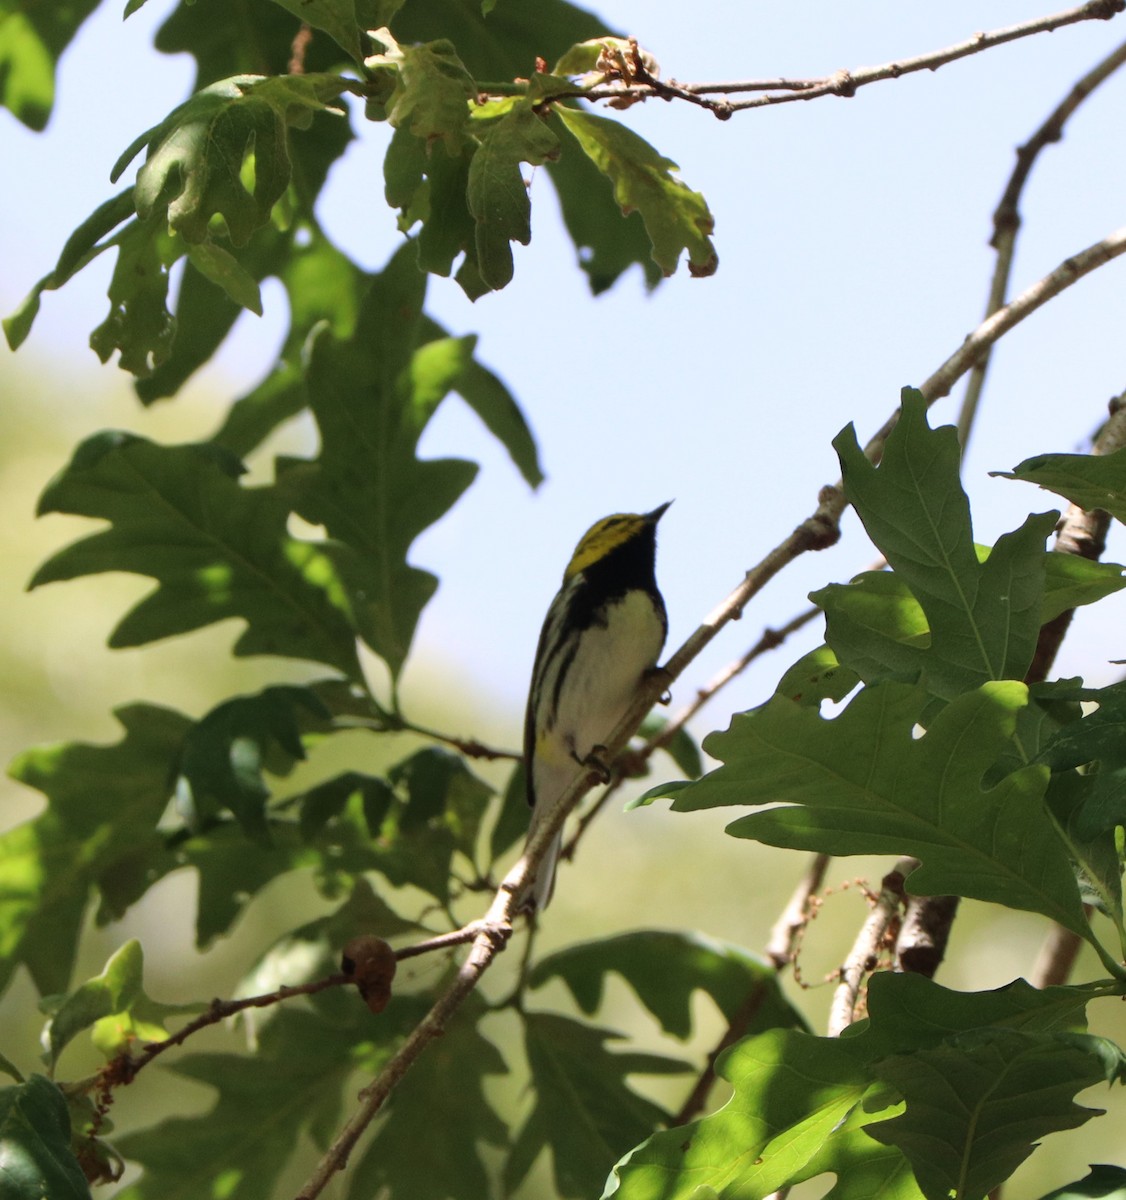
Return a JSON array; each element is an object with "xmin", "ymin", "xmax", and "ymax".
[{"xmin": 529, "ymin": 929, "xmax": 804, "ymax": 1039}]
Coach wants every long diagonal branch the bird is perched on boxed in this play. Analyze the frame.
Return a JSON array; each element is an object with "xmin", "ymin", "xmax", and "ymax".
[{"xmin": 298, "ymin": 229, "xmax": 1126, "ymax": 1200}]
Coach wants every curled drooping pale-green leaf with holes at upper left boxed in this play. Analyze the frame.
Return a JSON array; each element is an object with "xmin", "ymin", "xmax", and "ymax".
[{"xmin": 123, "ymin": 73, "xmax": 345, "ymax": 246}]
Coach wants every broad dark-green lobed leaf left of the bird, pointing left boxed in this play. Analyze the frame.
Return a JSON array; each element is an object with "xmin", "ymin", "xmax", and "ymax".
[{"xmin": 30, "ymin": 432, "xmax": 361, "ymax": 678}]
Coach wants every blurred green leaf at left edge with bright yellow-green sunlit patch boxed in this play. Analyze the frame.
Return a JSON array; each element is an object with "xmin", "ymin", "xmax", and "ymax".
[{"xmin": 0, "ymin": 704, "xmax": 191, "ymax": 995}]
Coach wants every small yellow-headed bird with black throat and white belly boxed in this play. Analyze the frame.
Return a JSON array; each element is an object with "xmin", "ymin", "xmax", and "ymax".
[{"xmin": 523, "ymin": 500, "xmax": 672, "ymax": 908}]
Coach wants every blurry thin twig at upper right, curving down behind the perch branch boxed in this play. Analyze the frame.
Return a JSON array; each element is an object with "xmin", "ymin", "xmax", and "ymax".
[{"xmin": 958, "ymin": 42, "xmax": 1126, "ymax": 450}]
